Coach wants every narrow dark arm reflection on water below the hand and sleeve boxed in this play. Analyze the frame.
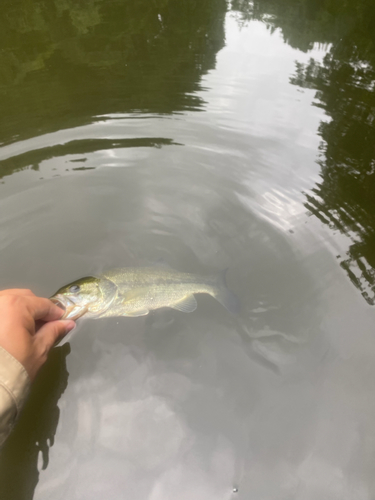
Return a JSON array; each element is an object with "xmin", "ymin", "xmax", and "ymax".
[{"xmin": 0, "ymin": 344, "xmax": 70, "ymax": 500}]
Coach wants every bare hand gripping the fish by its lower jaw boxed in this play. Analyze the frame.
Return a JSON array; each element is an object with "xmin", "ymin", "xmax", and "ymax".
[{"xmin": 0, "ymin": 289, "xmax": 75, "ymax": 380}]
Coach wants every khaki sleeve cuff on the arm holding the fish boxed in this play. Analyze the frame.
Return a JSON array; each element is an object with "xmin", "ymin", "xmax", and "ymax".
[{"xmin": 0, "ymin": 346, "xmax": 30, "ymax": 446}]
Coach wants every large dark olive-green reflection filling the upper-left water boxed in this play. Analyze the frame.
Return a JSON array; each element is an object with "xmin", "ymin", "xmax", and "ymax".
[{"xmin": 0, "ymin": 0, "xmax": 226, "ymax": 144}]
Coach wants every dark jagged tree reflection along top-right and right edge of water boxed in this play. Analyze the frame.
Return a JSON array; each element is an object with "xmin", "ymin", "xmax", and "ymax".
[{"xmin": 233, "ymin": 0, "xmax": 375, "ymax": 305}]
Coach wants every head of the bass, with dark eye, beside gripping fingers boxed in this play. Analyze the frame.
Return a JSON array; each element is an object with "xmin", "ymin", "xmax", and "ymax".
[{"xmin": 50, "ymin": 276, "xmax": 116, "ymax": 320}]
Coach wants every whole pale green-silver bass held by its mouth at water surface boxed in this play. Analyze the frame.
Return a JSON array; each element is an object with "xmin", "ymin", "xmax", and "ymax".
[{"xmin": 50, "ymin": 267, "xmax": 240, "ymax": 320}]
